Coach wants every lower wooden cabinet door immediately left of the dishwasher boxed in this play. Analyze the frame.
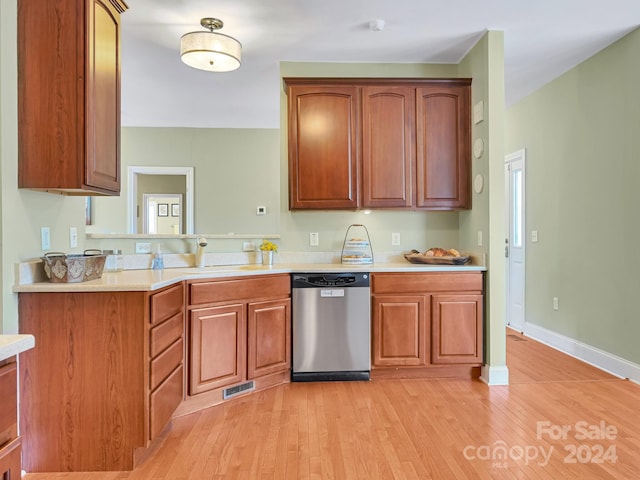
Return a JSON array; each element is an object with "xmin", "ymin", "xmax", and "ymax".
[{"xmin": 247, "ymin": 299, "xmax": 291, "ymax": 379}]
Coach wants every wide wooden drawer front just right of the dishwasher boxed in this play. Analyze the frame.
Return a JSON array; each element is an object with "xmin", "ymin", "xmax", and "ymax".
[{"xmin": 371, "ymin": 272, "xmax": 482, "ymax": 294}]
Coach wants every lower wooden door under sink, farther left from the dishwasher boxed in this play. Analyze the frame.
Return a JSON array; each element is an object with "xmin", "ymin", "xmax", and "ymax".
[{"xmin": 189, "ymin": 304, "xmax": 247, "ymax": 395}]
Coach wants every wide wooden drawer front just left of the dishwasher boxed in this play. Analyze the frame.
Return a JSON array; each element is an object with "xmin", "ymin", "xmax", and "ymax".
[{"xmin": 189, "ymin": 274, "xmax": 291, "ymax": 305}]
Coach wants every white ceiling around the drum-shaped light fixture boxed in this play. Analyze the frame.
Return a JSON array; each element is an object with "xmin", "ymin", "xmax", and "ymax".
[{"xmin": 122, "ymin": 0, "xmax": 640, "ymax": 128}]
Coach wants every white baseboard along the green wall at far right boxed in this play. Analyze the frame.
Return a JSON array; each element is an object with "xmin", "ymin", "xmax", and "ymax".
[{"xmin": 522, "ymin": 323, "xmax": 640, "ymax": 383}]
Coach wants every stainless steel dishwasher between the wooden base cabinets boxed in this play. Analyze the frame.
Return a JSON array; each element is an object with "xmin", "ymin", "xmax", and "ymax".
[{"xmin": 291, "ymin": 273, "xmax": 371, "ymax": 382}]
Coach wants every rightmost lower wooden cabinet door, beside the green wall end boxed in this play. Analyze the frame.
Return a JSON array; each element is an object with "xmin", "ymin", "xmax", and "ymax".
[{"xmin": 431, "ymin": 294, "xmax": 483, "ymax": 364}]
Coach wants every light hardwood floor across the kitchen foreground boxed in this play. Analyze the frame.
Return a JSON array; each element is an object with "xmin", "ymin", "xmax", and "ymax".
[{"xmin": 25, "ymin": 330, "xmax": 640, "ymax": 480}]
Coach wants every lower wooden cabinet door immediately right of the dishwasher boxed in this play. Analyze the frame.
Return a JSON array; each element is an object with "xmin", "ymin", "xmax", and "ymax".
[{"xmin": 372, "ymin": 295, "xmax": 428, "ymax": 367}]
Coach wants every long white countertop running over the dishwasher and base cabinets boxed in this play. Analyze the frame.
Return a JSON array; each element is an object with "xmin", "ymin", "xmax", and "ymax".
[{"xmin": 13, "ymin": 262, "xmax": 486, "ymax": 293}]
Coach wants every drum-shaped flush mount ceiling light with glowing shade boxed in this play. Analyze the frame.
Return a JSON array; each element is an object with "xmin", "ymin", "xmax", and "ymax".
[{"xmin": 180, "ymin": 18, "xmax": 242, "ymax": 72}]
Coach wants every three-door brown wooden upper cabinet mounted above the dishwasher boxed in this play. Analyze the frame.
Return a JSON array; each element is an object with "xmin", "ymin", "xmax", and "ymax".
[{"xmin": 285, "ymin": 78, "xmax": 471, "ymax": 210}]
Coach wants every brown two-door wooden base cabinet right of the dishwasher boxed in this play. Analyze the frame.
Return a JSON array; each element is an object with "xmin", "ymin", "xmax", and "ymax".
[{"xmin": 372, "ymin": 272, "xmax": 483, "ymax": 377}]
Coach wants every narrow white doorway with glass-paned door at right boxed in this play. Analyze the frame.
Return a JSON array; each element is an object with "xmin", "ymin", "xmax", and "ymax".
[{"xmin": 504, "ymin": 149, "xmax": 527, "ymax": 332}]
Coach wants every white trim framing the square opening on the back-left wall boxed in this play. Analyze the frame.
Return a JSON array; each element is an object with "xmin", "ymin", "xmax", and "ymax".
[{"xmin": 127, "ymin": 166, "xmax": 194, "ymax": 235}]
